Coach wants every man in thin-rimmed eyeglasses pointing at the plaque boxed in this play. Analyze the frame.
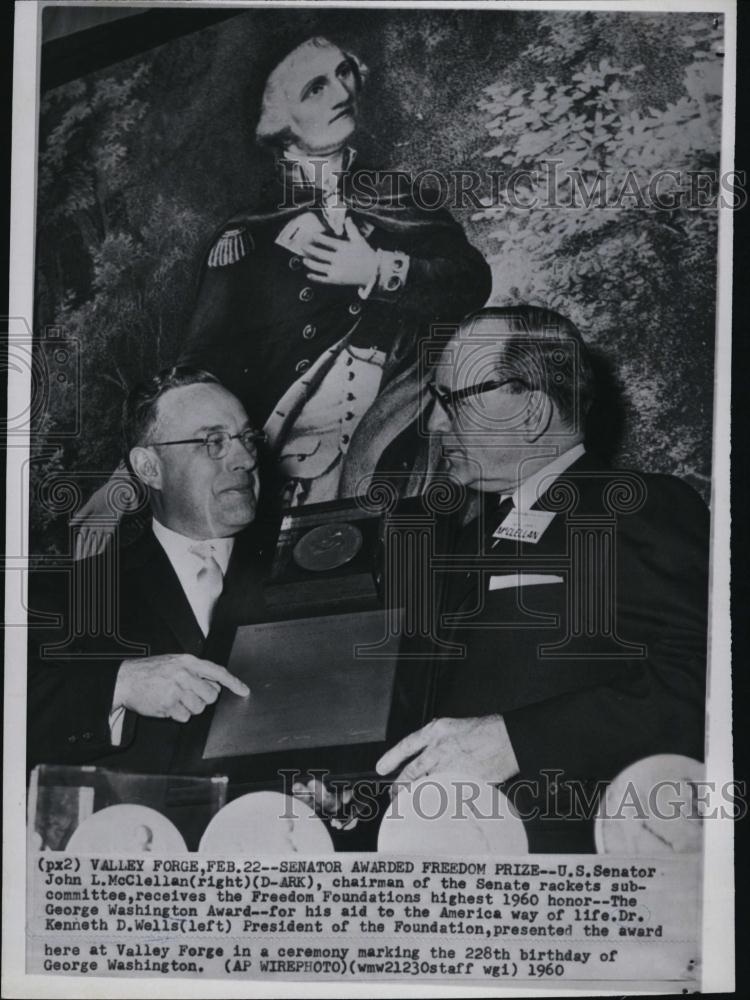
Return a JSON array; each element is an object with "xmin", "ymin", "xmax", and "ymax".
[{"xmin": 28, "ymin": 368, "xmax": 270, "ymax": 773}]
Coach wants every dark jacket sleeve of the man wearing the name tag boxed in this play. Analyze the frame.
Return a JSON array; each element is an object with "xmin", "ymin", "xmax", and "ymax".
[{"xmin": 504, "ymin": 476, "xmax": 709, "ymax": 778}]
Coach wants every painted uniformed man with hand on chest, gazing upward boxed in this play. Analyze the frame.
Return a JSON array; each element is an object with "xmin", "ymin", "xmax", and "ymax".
[{"xmin": 73, "ymin": 36, "xmax": 492, "ymax": 553}]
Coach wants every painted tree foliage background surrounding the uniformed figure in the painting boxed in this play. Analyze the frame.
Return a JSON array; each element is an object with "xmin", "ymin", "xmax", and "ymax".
[{"xmin": 32, "ymin": 9, "xmax": 722, "ymax": 551}]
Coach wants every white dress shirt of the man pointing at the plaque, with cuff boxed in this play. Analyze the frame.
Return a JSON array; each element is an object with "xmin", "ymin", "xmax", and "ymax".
[{"xmin": 109, "ymin": 518, "xmax": 234, "ymax": 746}]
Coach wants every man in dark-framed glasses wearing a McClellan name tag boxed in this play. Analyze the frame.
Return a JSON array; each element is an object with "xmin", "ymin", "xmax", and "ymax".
[{"xmin": 378, "ymin": 307, "xmax": 709, "ymax": 851}]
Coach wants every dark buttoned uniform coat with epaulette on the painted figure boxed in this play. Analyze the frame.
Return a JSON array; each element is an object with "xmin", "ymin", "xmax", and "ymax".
[{"xmin": 180, "ymin": 163, "xmax": 491, "ymax": 496}]
